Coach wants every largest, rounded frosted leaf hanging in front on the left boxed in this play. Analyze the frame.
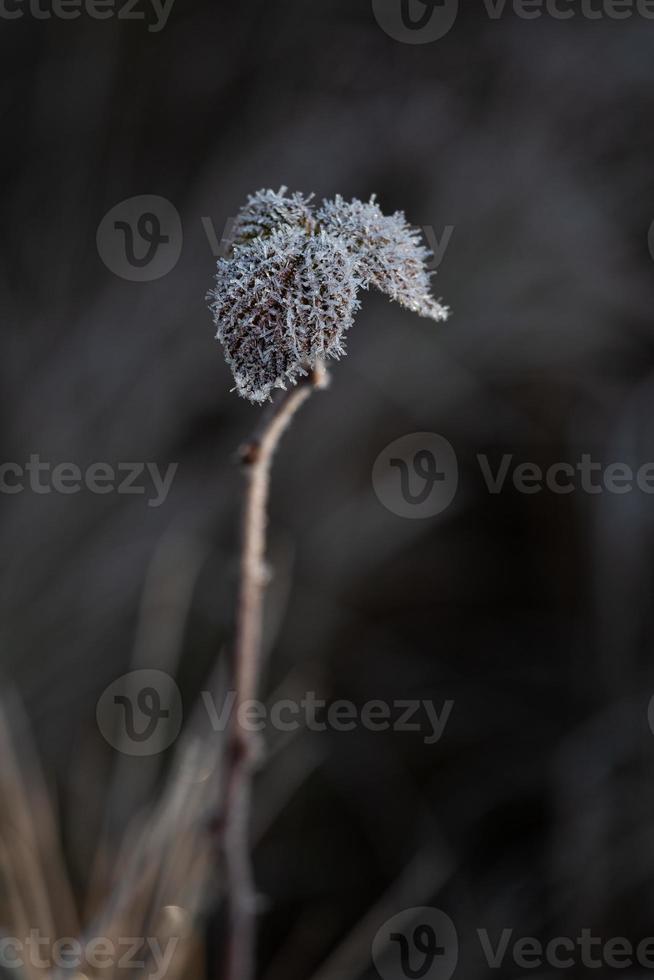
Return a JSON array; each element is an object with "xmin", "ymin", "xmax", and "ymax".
[{"xmin": 209, "ymin": 225, "xmax": 360, "ymax": 402}]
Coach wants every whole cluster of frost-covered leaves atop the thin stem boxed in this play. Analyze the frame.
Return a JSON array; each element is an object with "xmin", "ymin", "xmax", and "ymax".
[{"xmin": 208, "ymin": 187, "xmax": 447, "ymax": 402}]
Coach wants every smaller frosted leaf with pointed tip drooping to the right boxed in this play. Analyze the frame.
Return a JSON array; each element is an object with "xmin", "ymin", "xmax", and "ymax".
[{"xmin": 316, "ymin": 195, "xmax": 448, "ymax": 320}]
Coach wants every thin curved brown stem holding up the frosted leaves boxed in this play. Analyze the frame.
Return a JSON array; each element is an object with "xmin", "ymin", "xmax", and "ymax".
[{"xmin": 223, "ymin": 363, "xmax": 327, "ymax": 980}]
